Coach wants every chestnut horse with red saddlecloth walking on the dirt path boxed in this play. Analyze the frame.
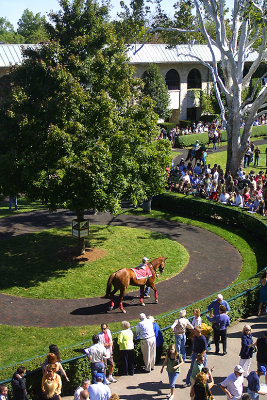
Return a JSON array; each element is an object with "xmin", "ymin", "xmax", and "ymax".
[{"xmin": 105, "ymin": 257, "xmax": 167, "ymax": 313}]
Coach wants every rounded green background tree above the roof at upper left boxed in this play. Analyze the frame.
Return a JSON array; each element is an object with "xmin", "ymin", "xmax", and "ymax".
[{"xmin": 17, "ymin": 8, "xmax": 48, "ymax": 43}]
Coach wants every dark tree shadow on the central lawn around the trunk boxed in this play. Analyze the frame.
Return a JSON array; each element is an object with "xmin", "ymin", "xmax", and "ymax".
[{"xmin": 0, "ymin": 227, "xmax": 107, "ymax": 290}]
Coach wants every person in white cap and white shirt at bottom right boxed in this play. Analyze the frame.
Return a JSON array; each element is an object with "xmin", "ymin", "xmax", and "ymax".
[{"xmin": 220, "ymin": 365, "xmax": 244, "ymax": 400}]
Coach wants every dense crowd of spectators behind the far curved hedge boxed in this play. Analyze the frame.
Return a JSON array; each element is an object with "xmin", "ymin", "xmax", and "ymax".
[{"xmin": 168, "ymin": 159, "xmax": 267, "ymax": 216}]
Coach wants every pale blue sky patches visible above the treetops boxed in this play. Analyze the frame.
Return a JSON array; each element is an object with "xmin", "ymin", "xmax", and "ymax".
[{"xmin": 0, "ymin": 0, "xmax": 234, "ymax": 29}]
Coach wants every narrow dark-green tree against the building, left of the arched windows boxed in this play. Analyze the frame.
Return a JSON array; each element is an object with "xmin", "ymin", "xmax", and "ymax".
[{"xmin": 143, "ymin": 64, "xmax": 171, "ymax": 119}]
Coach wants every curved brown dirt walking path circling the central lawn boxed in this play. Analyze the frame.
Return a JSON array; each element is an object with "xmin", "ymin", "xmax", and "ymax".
[{"xmin": 0, "ymin": 211, "xmax": 242, "ymax": 327}]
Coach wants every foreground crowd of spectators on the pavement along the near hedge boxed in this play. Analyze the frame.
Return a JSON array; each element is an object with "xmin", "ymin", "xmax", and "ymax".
[{"xmin": 6, "ymin": 300, "xmax": 267, "ymax": 400}]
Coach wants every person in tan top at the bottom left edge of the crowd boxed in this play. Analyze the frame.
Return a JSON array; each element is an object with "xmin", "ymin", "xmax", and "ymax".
[{"xmin": 42, "ymin": 364, "xmax": 62, "ymax": 400}]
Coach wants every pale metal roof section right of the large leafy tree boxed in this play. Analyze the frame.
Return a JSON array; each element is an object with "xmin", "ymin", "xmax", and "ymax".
[{"xmin": 128, "ymin": 43, "xmax": 257, "ymax": 64}]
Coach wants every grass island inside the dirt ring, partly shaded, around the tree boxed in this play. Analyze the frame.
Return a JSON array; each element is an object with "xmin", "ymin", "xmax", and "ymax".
[{"xmin": 0, "ymin": 226, "xmax": 189, "ymax": 299}]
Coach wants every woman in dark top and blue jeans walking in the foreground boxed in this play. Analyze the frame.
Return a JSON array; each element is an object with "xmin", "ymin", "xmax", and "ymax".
[{"xmin": 160, "ymin": 344, "xmax": 184, "ymax": 400}]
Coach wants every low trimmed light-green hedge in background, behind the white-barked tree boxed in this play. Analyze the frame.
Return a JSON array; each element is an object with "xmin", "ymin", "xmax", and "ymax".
[{"xmin": 175, "ymin": 125, "xmax": 267, "ymax": 148}]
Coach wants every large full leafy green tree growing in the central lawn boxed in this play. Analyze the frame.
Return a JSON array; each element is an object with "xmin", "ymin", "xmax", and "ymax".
[{"xmin": 0, "ymin": 0, "xmax": 170, "ymax": 255}]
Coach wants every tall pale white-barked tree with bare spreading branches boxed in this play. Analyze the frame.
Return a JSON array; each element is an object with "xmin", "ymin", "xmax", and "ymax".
[{"xmin": 138, "ymin": 0, "xmax": 267, "ymax": 174}]
